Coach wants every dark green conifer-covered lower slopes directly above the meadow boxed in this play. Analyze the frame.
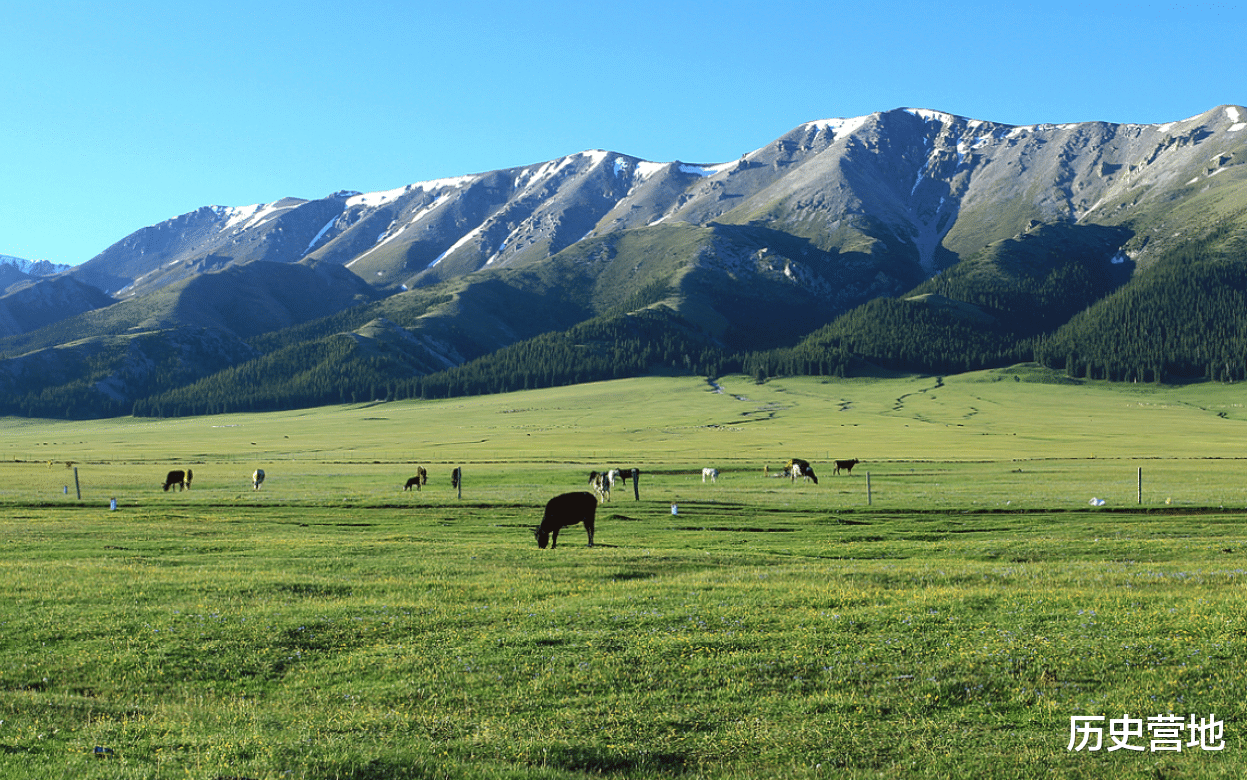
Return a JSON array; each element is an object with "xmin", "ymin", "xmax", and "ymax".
[{"xmin": 0, "ymin": 220, "xmax": 1247, "ymax": 417}]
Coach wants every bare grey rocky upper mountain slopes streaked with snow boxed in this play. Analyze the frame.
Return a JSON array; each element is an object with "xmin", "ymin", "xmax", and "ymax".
[{"xmin": 65, "ymin": 106, "xmax": 1247, "ymax": 304}]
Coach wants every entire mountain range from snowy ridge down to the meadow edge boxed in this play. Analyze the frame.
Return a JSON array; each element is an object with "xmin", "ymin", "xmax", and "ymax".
[{"xmin": 0, "ymin": 106, "xmax": 1247, "ymax": 416}]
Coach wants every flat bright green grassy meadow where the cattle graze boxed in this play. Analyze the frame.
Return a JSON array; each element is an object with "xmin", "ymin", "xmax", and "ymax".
[{"xmin": 0, "ymin": 368, "xmax": 1247, "ymax": 780}]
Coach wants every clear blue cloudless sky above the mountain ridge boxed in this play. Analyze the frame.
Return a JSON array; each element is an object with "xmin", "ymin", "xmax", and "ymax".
[{"xmin": 0, "ymin": 0, "xmax": 1247, "ymax": 264}]
